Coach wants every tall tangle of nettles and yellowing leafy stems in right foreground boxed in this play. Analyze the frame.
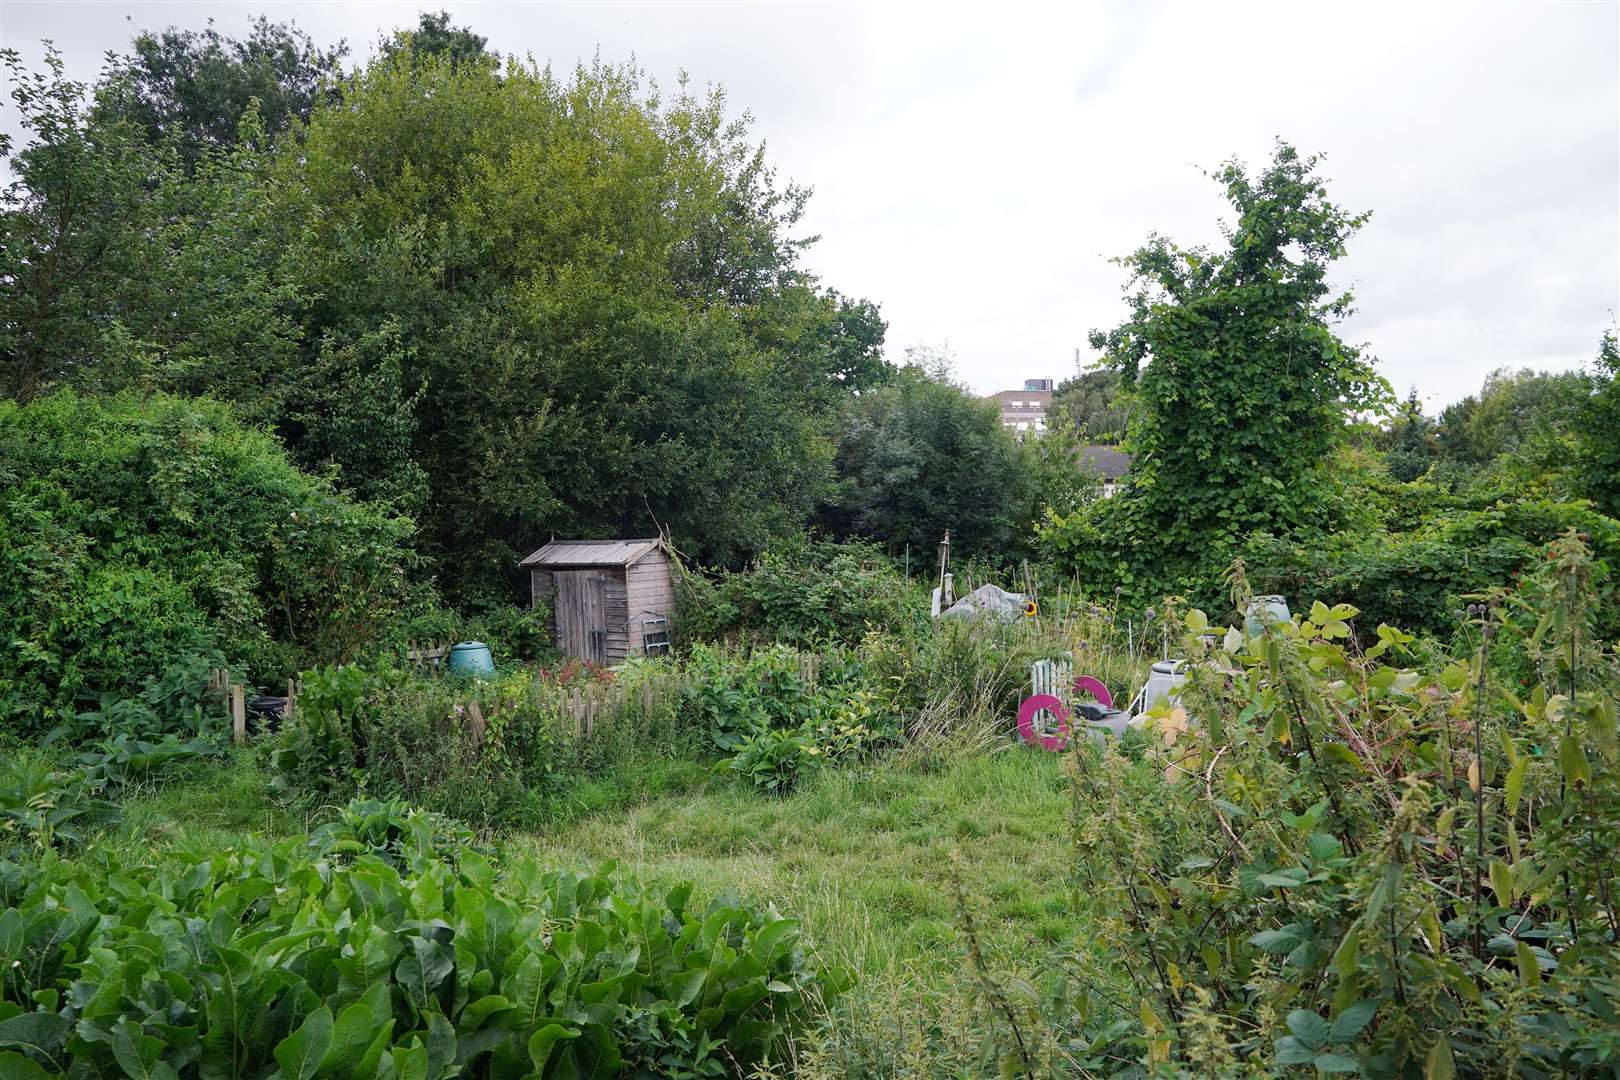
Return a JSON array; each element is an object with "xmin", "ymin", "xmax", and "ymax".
[{"xmin": 1072, "ymin": 534, "xmax": 1620, "ymax": 1078}]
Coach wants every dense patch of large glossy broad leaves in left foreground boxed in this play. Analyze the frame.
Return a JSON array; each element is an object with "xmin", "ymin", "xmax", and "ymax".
[{"xmin": 0, "ymin": 822, "xmax": 849, "ymax": 1080}]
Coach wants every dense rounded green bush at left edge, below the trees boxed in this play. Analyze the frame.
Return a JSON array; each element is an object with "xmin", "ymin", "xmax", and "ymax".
[{"xmin": 0, "ymin": 392, "xmax": 413, "ymax": 732}]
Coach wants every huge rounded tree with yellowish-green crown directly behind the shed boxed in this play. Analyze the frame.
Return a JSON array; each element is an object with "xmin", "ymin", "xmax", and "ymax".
[{"xmin": 269, "ymin": 50, "xmax": 883, "ymax": 588}]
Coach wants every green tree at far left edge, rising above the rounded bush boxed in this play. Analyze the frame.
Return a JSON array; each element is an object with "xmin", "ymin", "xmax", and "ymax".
[{"xmin": 0, "ymin": 52, "xmax": 301, "ymax": 408}]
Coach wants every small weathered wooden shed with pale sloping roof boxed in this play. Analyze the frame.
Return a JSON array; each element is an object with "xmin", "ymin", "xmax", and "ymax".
[{"xmin": 518, "ymin": 536, "xmax": 676, "ymax": 664}]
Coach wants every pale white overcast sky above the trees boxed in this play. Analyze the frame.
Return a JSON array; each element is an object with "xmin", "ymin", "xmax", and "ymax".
[{"xmin": 0, "ymin": 0, "xmax": 1620, "ymax": 410}]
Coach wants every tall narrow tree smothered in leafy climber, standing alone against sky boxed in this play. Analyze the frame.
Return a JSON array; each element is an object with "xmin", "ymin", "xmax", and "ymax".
[{"xmin": 1045, "ymin": 144, "xmax": 1388, "ymax": 597}]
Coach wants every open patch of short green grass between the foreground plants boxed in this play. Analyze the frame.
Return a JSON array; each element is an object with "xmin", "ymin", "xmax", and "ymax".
[{"xmin": 510, "ymin": 748, "xmax": 1084, "ymax": 1075}]
